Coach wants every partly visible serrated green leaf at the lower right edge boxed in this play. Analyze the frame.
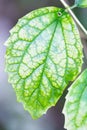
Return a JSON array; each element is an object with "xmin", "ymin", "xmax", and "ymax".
[{"xmin": 63, "ymin": 69, "xmax": 87, "ymax": 130}]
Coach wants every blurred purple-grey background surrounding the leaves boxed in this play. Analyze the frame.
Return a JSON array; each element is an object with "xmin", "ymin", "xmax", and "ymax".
[{"xmin": 0, "ymin": 0, "xmax": 87, "ymax": 130}]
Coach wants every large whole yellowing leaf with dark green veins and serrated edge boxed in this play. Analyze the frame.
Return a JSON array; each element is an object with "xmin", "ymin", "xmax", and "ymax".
[{"xmin": 6, "ymin": 7, "xmax": 82, "ymax": 118}]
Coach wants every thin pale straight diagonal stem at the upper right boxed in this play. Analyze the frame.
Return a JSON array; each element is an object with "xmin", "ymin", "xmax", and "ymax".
[{"xmin": 60, "ymin": 0, "xmax": 87, "ymax": 35}]
